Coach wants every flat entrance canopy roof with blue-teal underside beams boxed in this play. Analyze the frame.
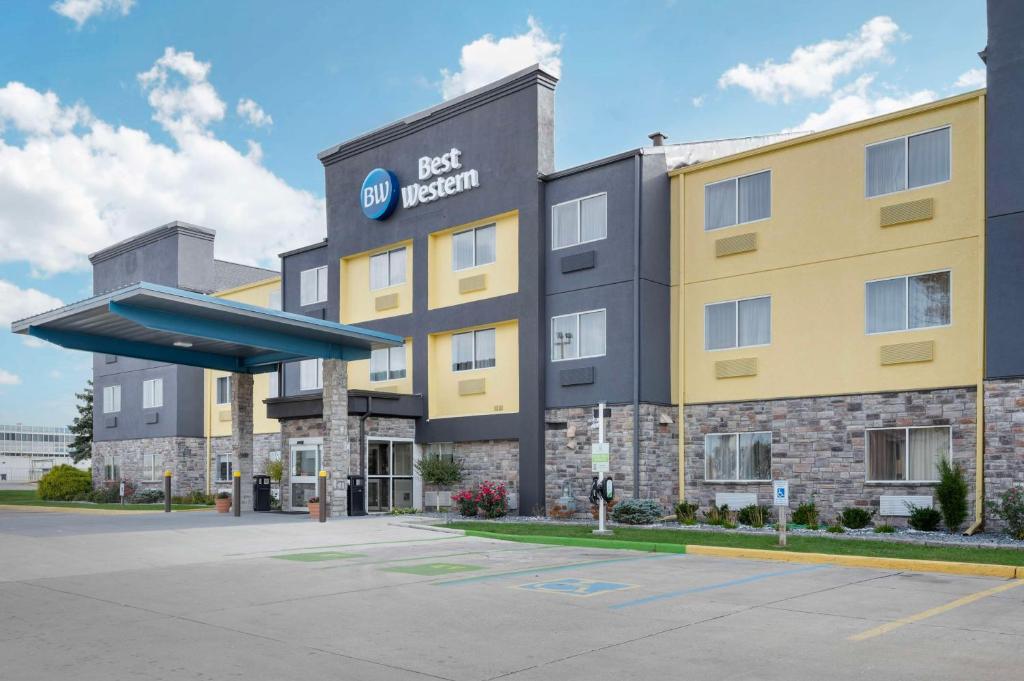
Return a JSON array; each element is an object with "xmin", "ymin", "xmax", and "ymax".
[{"xmin": 11, "ymin": 282, "xmax": 402, "ymax": 374}]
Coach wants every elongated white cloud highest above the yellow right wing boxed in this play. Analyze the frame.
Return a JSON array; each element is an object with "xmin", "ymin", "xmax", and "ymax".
[{"xmin": 718, "ymin": 16, "xmax": 900, "ymax": 102}]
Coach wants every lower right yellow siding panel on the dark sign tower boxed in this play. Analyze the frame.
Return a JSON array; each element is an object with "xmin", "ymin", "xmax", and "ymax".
[{"xmin": 427, "ymin": 321, "xmax": 519, "ymax": 419}]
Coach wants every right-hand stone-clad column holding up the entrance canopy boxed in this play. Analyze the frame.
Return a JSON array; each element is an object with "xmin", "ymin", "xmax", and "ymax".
[{"xmin": 322, "ymin": 359, "xmax": 350, "ymax": 516}]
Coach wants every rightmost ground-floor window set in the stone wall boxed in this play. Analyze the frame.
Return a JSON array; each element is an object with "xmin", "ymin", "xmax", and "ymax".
[{"xmin": 865, "ymin": 426, "xmax": 951, "ymax": 482}]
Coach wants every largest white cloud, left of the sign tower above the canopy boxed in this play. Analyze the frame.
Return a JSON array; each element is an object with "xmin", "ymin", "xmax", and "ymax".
[{"xmin": 0, "ymin": 48, "xmax": 326, "ymax": 274}]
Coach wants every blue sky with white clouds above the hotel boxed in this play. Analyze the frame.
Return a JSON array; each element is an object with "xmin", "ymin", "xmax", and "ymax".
[{"xmin": 0, "ymin": 0, "xmax": 986, "ymax": 425}]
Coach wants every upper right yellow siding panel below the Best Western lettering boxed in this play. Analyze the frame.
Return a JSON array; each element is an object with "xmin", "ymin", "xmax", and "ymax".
[{"xmin": 427, "ymin": 211, "xmax": 519, "ymax": 309}]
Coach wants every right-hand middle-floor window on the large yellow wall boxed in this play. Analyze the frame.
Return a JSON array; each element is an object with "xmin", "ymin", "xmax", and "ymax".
[{"xmin": 865, "ymin": 270, "xmax": 950, "ymax": 334}]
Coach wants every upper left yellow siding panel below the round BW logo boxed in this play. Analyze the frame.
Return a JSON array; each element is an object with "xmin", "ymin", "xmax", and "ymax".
[{"xmin": 339, "ymin": 241, "xmax": 413, "ymax": 324}]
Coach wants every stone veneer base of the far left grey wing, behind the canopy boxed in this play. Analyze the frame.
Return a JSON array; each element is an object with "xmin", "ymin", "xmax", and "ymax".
[{"xmin": 92, "ymin": 437, "xmax": 206, "ymax": 495}]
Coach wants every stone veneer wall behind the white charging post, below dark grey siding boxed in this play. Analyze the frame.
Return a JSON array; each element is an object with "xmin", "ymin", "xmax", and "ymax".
[{"xmin": 544, "ymin": 402, "xmax": 679, "ymax": 511}]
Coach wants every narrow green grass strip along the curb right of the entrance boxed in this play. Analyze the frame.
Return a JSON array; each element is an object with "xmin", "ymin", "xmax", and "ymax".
[{"xmin": 447, "ymin": 520, "xmax": 1024, "ymax": 565}]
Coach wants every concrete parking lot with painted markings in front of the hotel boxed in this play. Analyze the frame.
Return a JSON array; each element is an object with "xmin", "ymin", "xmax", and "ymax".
[{"xmin": 0, "ymin": 510, "xmax": 1024, "ymax": 681}]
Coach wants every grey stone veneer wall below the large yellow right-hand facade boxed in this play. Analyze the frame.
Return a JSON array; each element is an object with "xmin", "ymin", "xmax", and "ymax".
[{"xmin": 684, "ymin": 387, "xmax": 976, "ymax": 523}]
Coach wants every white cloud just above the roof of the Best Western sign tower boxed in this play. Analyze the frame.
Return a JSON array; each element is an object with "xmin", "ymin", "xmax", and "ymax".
[{"xmin": 440, "ymin": 16, "xmax": 562, "ymax": 99}]
